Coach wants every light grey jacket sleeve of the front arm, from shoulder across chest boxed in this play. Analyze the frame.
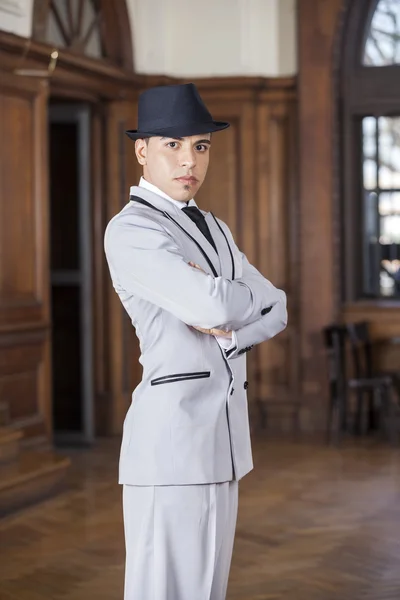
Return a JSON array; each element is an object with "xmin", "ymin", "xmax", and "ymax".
[{"xmin": 105, "ymin": 212, "xmax": 282, "ymax": 329}]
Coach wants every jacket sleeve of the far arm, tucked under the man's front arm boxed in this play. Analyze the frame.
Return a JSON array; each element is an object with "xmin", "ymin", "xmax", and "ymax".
[{"xmin": 226, "ymin": 254, "xmax": 288, "ymax": 359}]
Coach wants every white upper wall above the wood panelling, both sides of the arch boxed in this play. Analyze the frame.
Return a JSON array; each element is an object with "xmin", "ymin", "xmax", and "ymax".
[{"xmin": 0, "ymin": 0, "xmax": 297, "ymax": 77}]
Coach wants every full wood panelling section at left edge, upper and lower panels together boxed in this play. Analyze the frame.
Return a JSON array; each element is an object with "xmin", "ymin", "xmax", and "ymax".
[{"xmin": 0, "ymin": 73, "xmax": 51, "ymax": 441}]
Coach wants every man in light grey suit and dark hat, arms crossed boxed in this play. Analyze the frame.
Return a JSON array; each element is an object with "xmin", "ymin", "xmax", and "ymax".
[{"xmin": 105, "ymin": 84, "xmax": 287, "ymax": 600}]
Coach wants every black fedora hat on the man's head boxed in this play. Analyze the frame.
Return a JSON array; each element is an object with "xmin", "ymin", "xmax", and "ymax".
[{"xmin": 125, "ymin": 83, "xmax": 229, "ymax": 140}]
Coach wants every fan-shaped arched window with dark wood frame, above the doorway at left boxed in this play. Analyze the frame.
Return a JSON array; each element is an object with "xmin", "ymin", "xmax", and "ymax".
[{"xmin": 32, "ymin": 0, "xmax": 133, "ymax": 69}]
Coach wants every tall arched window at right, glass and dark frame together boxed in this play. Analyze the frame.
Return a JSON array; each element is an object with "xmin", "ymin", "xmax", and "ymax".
[{"xmin": 341, "ymin": 0, "xmax": 400, "ymax": 301}]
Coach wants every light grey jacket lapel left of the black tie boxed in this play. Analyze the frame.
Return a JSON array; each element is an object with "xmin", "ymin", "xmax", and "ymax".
[{"xmin": 131, "ymin": 186, "xmax": 222, "ymax": 275}]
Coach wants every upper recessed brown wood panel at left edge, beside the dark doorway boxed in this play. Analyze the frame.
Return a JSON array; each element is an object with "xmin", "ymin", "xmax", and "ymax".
[{"xmin": 0, "ymin": 74, "xmax": 48, "ymax": 331}]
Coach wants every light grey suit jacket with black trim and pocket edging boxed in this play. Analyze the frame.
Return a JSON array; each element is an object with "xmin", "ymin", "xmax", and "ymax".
[{"xmin": 105, "ymin": 187, "xmax": 287, "ymax": 485}]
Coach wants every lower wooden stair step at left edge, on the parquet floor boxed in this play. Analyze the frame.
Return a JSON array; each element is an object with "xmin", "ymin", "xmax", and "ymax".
[{"xmin": 0, "ymin": 450, "xmax": 71, "ymax": 516}]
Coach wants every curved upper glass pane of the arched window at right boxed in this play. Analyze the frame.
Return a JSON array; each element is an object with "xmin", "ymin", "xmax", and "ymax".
[{"xmin": 363, "ymin": 0, "xmax": 400, "ymax": 67}]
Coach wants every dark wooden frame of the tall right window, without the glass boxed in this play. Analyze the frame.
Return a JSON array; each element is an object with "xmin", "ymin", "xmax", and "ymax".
[{"xmin": 339, "ymin": 0, "xmax": 400, "ymax": 304}]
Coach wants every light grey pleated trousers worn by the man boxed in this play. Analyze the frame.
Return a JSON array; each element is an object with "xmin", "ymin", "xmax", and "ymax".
[{"xmin": 123, "ymin": 481, "xmax": 238, "ymax": 600}]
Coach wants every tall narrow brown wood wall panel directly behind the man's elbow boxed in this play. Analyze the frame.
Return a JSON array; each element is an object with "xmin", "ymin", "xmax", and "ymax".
[{"xmin": 256, "ymin": 98, "xmax": 299, "ymax": 410}]
